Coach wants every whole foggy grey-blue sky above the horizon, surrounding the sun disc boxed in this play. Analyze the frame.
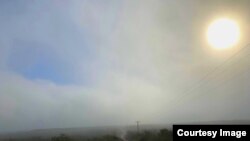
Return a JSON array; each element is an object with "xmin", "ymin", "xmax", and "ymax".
[{"xmin": 0, "ymin": 0, "xmax": 250, "ymax": 132}]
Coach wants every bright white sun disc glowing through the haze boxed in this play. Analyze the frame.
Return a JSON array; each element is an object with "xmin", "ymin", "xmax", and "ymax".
[{"xmin": 207, "ymin": 18, "xmax": 240, "ymax": 49}]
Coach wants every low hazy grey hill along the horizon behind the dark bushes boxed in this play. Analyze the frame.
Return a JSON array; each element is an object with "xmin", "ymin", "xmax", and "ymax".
[{"xmin": 0, "ymin": 120, "xmax": 250, "ymax": 140}]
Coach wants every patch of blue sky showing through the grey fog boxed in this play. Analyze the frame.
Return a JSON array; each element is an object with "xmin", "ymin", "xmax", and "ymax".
[{"xmin": 8, "ymin": 41, "xmax": 74, "ymax": 84}]
